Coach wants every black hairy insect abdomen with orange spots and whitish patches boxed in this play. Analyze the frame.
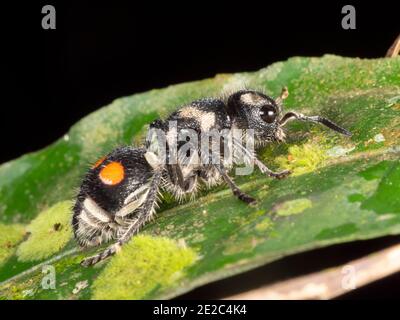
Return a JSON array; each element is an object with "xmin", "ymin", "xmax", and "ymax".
[{"xmin": 72, "ymin": 147, "xmax": 152, "ymax": 247}]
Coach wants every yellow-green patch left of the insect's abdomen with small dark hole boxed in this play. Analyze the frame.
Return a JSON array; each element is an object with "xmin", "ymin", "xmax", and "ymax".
[{"xmin": 17, "ymin": 201, "xmax": 72, "ymax": 261}]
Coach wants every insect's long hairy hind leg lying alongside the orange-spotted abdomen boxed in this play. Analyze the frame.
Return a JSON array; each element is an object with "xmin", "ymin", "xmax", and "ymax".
[{"xmin": 81, "ymin": 169, "xmax": 162, "ymax": 267}]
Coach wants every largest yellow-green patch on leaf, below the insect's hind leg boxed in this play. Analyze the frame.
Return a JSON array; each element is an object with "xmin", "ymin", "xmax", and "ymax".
[{"xmin": 93, "ymin": 235, "xmax": 197, "ymax": 299}]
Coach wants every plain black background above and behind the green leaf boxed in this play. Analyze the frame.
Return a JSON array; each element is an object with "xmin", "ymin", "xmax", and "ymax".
[{"xmin": 0, "ymin": 1, "xmax": 400, "ymax": 297}]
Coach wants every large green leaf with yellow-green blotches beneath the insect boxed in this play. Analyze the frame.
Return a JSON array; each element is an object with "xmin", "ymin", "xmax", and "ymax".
[{"xmin": 0, "ymin": 55, "xmax": 400, "ymax": 299}]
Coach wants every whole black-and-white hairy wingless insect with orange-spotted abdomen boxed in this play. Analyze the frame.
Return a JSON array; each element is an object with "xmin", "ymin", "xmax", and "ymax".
[{"xmin": 73, "ymin": 88, "xmax": 351, "ymax": 266}]
